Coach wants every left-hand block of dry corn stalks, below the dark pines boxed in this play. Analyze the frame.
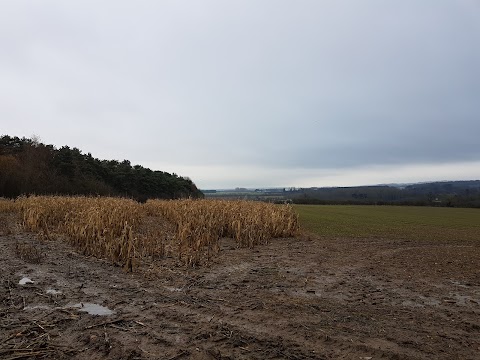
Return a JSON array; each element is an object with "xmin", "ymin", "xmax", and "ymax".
[{"xmin": 15, "ymin": 196, "xmax": 141, "ymax": 270}]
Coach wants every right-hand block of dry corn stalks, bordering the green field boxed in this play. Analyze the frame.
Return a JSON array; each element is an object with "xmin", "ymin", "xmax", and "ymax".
[{"xmin": 144, "ymin": 200, "xmax": 298, "ymax": 265}]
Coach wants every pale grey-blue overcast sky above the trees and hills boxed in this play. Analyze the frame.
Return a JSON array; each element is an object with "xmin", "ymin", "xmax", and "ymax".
[{"xmin": 0, "ymin": 0, "xmax": 480, "ymax": 189}]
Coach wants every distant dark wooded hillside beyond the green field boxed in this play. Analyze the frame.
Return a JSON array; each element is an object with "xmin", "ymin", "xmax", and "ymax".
[{"xmin": 289, "ymin": 180, "xmax": 480, "ymax": 208}]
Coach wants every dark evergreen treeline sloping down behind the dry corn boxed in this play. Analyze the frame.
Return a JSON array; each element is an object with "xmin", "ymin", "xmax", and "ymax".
[{"xmin": 0, "ymin": 135, "xmax": 203, "ymax": 201}]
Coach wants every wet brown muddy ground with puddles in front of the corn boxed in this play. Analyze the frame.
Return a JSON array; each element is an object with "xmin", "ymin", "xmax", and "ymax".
[{"xmin": 0, "ymin": 215, "xmax": 480, "ymax": 360}]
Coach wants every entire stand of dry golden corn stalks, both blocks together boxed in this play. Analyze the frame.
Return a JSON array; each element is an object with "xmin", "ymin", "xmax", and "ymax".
[{"xmin": 0, "ymin": 196, "xmax": 299, "ymax": 271}]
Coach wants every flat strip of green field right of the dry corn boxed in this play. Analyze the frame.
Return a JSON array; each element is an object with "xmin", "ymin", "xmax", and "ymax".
[{"xmin": 294, "ymin": 205, "xmax": 480, "ymax": 241}]
